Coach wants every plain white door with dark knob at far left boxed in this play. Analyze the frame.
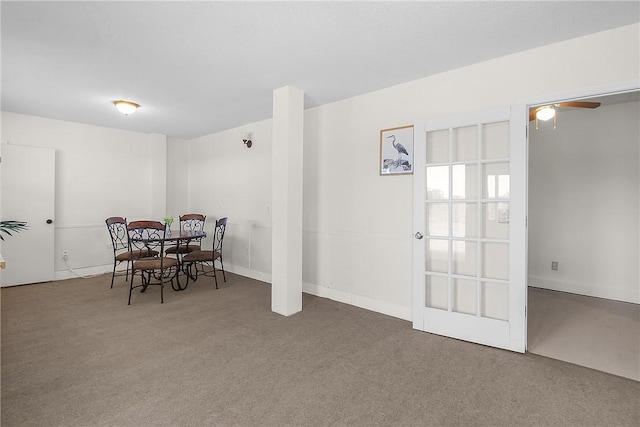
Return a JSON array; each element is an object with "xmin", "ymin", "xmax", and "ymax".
[{"xmin": 0, "ymin": 144, "xmax": 55, "ymax": 286}]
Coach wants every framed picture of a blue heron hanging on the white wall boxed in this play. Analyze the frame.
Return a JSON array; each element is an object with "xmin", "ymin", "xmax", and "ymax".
[{"xmin": 380, "ymin": 126, "xmax": 413, "ymax": 175}]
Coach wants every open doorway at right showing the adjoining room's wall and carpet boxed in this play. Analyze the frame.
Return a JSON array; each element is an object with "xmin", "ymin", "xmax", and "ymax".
[{"xmin": 527, "ymin": 90, "xmax": 640, "ymax": 380}]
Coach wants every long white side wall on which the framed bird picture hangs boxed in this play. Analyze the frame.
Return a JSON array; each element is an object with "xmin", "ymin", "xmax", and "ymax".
[{"xmin": 189, "ymin": 25, "xmax": 640, "ymax": 320}]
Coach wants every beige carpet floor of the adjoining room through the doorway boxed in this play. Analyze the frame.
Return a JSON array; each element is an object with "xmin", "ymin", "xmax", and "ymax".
[{"xmin": 528, "ymin": 288, "xmax": 640, "ymax": 382}]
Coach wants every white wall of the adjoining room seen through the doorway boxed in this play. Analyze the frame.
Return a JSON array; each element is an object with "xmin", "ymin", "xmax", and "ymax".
[{"xmin": 529, "ymin": 102, "xmax": 640, "ymax": 304}]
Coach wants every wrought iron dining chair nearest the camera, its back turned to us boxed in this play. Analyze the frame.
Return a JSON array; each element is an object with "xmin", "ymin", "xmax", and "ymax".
[{"xmin": 127, "ymin": 221, "xmax": 179, "ymax": 304}]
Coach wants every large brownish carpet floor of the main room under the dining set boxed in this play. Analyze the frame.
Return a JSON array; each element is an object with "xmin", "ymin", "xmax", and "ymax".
[{"xmin": 1, "ymin": 274, "xmax": 640, "ymax": 427}]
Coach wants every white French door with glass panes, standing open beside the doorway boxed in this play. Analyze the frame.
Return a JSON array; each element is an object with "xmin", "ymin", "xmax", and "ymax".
[{"xmin": 413, "ymin": 105, "xmax": 527, "ymax": 352}]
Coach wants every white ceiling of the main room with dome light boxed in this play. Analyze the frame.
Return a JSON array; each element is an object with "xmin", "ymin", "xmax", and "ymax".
[{"xmin": 0, "ymin": 1, "xmax": 640, "ymax": 139}]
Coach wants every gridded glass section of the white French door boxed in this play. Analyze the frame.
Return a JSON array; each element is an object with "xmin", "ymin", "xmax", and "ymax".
[{"xmin": 424, "ymin": 122, "xmax": 510, "ymax": 319}]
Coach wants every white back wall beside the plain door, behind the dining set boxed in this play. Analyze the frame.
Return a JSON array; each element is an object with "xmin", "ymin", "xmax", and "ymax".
[{"xmin": 1, "ymin": 112, "xmax": 167, "ymax": 279}]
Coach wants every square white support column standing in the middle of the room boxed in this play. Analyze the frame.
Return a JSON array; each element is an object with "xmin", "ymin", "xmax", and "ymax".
[{"xmin": 271, "ymin": 86, "xmax": 304, "ymax": 316}]
